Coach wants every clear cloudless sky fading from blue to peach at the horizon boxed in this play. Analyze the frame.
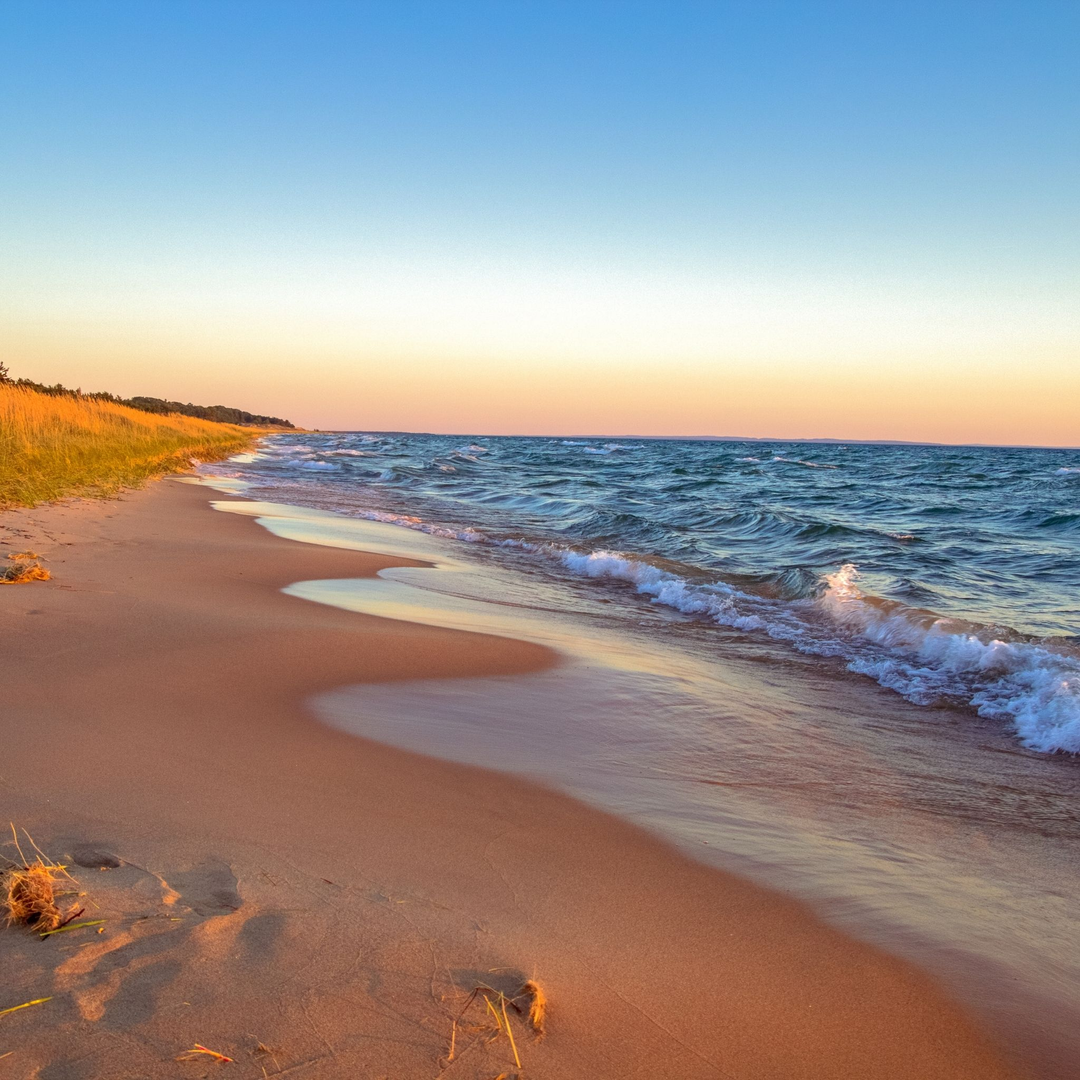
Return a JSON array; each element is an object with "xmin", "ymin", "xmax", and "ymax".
[{"xmin": 0, "ymin": 0, "xmax": 1080, "ymax": 446}]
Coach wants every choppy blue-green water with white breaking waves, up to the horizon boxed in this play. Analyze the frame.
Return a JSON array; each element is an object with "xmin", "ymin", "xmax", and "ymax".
[{"xmin": 215, "ymin": 434, "xmax": 1080, "ymax": 754}]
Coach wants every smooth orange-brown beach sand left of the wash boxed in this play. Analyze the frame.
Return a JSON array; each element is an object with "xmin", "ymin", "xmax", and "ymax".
[{"xmin": 0, "ymin": 483, "xmax": 1013, "ymax": 1080}]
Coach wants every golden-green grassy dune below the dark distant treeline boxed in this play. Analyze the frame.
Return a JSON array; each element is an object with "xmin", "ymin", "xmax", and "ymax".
[{"xmin": 0, "ymin": 386, "xmax": 258, "ymax": 508}]
